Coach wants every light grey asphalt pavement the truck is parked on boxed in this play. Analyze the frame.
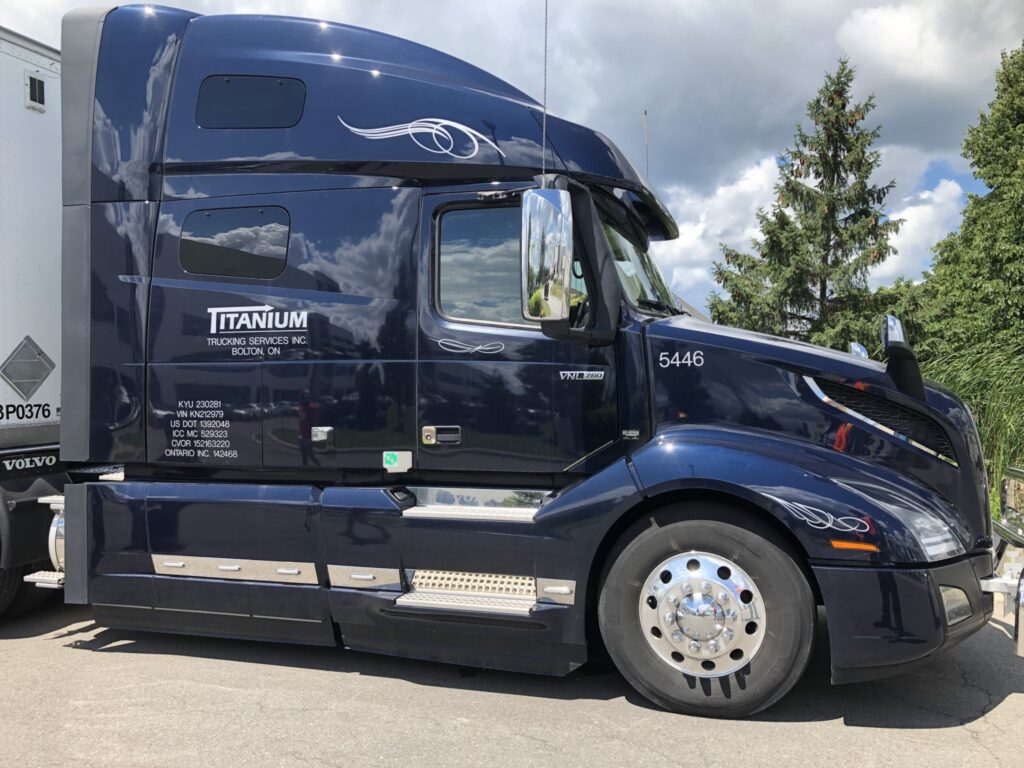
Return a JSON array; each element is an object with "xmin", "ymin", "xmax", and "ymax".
[{"xmin": 0, "ymin": 602, "xmax": 1024, "ymax": 768}]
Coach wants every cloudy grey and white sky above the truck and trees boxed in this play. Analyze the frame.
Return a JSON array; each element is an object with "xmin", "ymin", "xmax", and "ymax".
[{"xmin": 6, "ymin": 0, "xmax": 1024, "ymax": 313}]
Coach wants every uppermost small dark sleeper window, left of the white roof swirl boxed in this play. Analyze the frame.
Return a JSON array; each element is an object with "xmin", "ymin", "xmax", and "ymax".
[{"xmin": 196, "ymin": 75, "xmax": 306, "ymax": 128}]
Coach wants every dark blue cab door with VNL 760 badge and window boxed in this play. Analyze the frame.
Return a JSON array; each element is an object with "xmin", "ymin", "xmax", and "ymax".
[{"xmin": 417, "ymin": 194, "xmax": 617, "ymax": 473}]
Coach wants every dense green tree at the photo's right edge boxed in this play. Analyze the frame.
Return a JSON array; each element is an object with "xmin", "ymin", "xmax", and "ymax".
[{"xmin": 916, "ymin": 48, "xmax": 1024, "ymax": 495}]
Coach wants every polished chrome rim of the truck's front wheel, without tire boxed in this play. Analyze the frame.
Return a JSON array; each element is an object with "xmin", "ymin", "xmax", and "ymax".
[{"xmin": 639, "ymin": 551, "xmax": 766, "ymax": 678}]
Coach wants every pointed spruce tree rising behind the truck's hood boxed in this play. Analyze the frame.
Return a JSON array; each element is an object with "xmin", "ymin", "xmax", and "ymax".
[{"xmin": 709, "ymin": 59, "xmax": 900, "ymax": 346}]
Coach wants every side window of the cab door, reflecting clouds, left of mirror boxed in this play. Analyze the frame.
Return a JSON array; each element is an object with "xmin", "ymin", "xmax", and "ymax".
[{"xmin": 438, "ymin": 208, "xmax": 528, "ymax": 326}]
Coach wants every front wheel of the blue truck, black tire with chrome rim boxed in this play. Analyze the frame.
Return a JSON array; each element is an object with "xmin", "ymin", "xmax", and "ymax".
[{"xmin": 598, "ymin": 505, "xmax": 815, "ymax": 718}]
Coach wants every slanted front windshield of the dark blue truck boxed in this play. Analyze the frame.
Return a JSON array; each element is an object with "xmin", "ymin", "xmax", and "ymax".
[{"xmin": 595, "ymin": 196, "xmax": 678, "ymax": 314}]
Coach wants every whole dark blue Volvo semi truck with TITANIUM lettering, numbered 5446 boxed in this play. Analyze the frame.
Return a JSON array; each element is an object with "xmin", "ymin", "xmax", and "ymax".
[{"xmin": 49, "ymin": 6, "xmax": 1019, "ymax": 717}]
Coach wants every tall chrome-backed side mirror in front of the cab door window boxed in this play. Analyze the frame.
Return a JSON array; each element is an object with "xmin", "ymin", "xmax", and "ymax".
[{"xmin": 522, "ymin": 189, "xmax": 572, "ymax": 321}]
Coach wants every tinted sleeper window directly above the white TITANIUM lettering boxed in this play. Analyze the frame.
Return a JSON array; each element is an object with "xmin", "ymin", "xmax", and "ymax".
[{"xmin": 180, "ymin": 206, "xmax": 291, "ymax": 280}]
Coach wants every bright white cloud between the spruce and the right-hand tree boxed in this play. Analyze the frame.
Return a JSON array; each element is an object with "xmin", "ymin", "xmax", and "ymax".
[{"xmin": 870, "ymin": 179, "xmax": 966, "ymax": 286}]
